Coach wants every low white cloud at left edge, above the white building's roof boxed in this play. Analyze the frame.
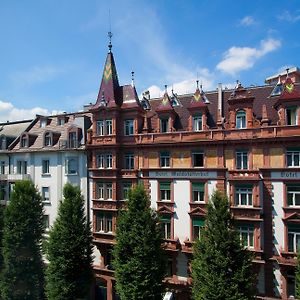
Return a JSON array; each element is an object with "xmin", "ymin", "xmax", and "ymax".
[{"xmin": 0, "ymin": 100, "xmax": 59, "ymax": 122}]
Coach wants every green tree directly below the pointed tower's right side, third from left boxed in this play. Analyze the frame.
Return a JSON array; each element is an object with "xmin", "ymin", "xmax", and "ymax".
[{"xmin": 113, "ymin": 185, "xmax": 166, "ymax": 300}]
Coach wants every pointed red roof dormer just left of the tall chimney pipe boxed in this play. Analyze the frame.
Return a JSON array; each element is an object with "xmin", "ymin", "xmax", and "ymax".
[{"xmin": 188, "ymin": 80, "xmax": 209, "ymax": 131}]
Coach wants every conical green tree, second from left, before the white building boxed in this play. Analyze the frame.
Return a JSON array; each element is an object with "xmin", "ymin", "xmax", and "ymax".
[{"xmin": 46, "ymin": 183, "xmax": 93, "ymax": 300}]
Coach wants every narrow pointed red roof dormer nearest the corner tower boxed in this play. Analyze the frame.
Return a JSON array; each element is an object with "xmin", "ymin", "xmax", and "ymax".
[{"xmin": 156, "ymin": 86, "xmax": 176, "ymax": 133}]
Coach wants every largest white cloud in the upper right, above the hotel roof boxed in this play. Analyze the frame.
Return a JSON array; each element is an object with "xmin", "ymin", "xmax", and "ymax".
[{"xmin": 216, "ymin": 38, "xmax": 281, "ymax": 76}]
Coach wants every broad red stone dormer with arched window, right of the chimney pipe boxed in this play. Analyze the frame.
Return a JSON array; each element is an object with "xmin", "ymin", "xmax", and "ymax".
[{"xmin": 225, "ymin": 82, "xmax": 259, "ymax": 129}]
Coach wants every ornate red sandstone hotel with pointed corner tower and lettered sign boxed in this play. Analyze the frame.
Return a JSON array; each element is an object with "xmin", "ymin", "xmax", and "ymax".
[{"xmin": 86, "ymin": 46, "xmax": 300, "ymax": 300}]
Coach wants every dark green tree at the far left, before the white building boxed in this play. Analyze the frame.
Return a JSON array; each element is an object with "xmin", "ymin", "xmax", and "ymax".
[{"xmin": 1, "ymin": 180, "xmax": 44, "ymax": 300}]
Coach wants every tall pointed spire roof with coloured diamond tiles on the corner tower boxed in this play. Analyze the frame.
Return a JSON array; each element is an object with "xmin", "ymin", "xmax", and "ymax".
[{"xmin": 93, "ymin": 32, "xmax": 122, "ymax": 109}]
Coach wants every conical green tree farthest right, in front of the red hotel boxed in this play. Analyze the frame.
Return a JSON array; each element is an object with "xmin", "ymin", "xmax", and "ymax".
[{"xmin": 192, "ymin": 191, "xmax": 255, "ymax": 300}]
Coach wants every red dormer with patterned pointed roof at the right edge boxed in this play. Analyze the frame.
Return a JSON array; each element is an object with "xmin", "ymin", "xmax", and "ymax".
[{"xmin": 274, "ymin": 75, "xmax": 300, "ymax": 125}]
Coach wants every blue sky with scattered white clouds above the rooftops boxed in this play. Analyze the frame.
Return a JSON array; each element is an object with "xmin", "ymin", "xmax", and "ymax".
[{"xmin": 0, "ymin": 0, "xmax": 300, "ymax": 121}]
